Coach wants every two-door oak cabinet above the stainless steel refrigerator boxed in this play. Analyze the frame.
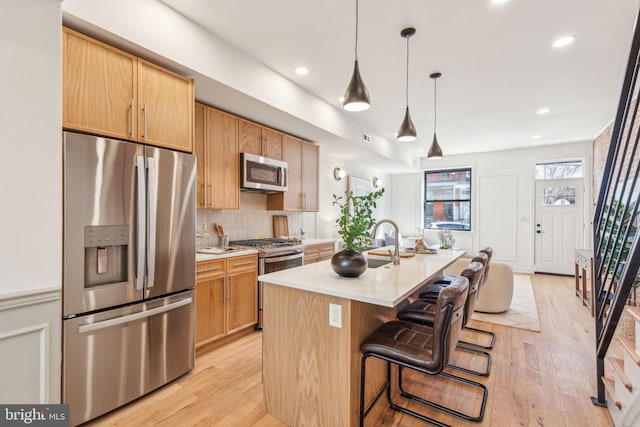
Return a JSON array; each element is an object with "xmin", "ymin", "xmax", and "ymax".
[{"xmin": 62, "ymin": 27, "xmax": 194, "ymax": 152}]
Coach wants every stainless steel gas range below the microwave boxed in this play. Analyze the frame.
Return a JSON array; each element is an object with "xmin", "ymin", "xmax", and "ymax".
[{"xmin": 229, "ymin": 238, "xmax": 304, "ymax": 330}]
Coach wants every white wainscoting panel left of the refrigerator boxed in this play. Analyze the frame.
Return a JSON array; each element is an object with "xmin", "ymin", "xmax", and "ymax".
[{"xmin": 0, "ymin": 288, "xmax": 62, "ymax": 404}]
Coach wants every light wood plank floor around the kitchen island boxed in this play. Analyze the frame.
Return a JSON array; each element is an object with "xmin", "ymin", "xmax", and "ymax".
[{"xmin": 88, "ymin": 275, "xmax": 613, "ymax": 427}]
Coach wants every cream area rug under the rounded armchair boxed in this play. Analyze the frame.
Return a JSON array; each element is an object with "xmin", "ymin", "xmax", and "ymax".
[{"xmin": 471, "ymin": 274, "xmax": 540, "ymax": 332}]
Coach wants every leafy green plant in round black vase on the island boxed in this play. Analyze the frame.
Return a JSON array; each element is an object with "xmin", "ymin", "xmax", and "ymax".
[{"xmin": 331, "ymin": 188, "xmax": 384, "ymax": 277}]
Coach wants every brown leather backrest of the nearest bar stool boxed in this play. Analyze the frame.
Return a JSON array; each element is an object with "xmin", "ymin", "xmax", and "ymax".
[{"xmin": 432, "ymin": 276, "xmax": 469, "ymax": 367}]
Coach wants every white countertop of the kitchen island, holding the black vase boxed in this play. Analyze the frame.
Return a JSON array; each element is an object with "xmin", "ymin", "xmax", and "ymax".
[{"xmin": 258, "ymin": 249, "xmax": 465, "ymax": 307}]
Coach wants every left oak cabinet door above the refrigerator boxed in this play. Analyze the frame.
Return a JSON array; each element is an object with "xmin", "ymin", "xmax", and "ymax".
[{"xmin": 62, "ymin": 28, "xmax": 137, "ymax": 140}]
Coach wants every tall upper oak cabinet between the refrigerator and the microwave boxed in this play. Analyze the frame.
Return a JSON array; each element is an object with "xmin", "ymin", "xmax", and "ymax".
[{"xmin": 194, "ymin": 104, "xmax": 240, "ymax": 209}]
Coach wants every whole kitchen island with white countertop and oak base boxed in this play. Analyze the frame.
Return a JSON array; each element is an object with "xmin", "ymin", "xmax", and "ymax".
[{"xmin": 259, "ymin": 250, "xmax": 464, "ymax": 426}]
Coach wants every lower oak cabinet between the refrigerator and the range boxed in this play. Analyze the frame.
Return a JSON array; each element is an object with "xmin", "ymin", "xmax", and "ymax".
[{"xmin": 196, "ymin": 254, "xmax": 258, "ymax": 346}]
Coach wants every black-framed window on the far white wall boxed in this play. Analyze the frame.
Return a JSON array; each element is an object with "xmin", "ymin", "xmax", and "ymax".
[{"xmin": 424, "ymin": 168, "xmax": 471, "ymax": 231}]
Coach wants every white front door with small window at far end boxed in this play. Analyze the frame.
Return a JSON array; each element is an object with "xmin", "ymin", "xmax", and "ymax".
[{"xmin": 534, "ymin": 179, "xmax": 584, "ymax": 275}]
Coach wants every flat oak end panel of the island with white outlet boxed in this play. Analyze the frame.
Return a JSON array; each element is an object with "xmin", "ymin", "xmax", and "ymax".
[{"xmin": 262, "ymin": 283, "xmax": 354, "ymax": 426}]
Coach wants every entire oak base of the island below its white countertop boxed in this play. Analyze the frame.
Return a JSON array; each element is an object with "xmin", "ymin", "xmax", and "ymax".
[{"xmin": 262, "ymin": 283, "xmax": 419, "ymax": 426}]
